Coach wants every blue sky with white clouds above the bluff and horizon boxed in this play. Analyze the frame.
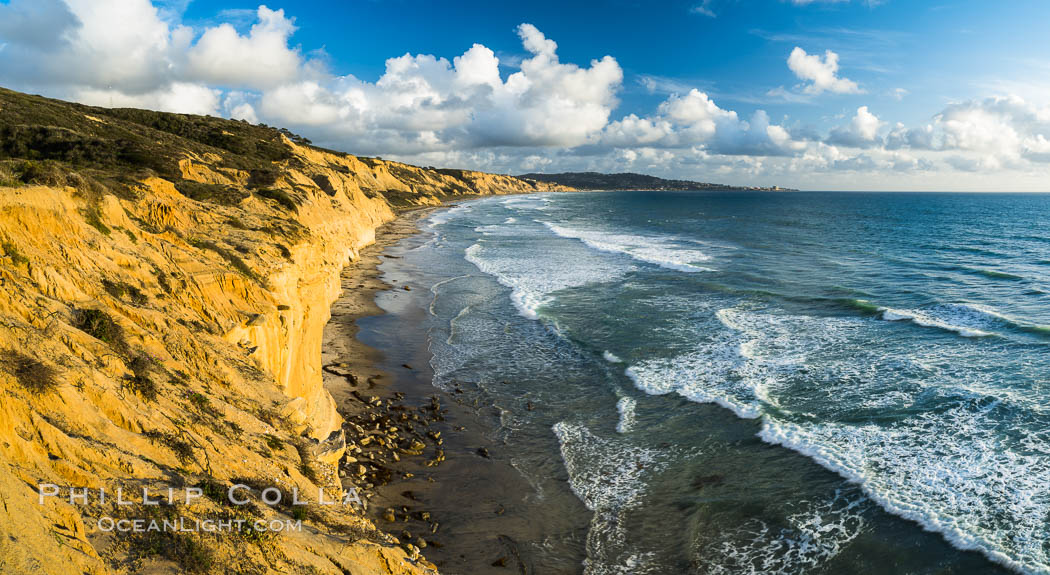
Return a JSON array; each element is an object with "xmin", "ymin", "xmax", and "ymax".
[{"xmin": 0, "ymin": 0, "xmax": 1050, "ymax": 191}]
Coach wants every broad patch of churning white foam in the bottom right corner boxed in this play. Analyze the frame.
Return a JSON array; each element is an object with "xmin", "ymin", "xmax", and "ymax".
[{"xmin": 759, "ymin": 409, "xmax": 1050, "ymax": 573}]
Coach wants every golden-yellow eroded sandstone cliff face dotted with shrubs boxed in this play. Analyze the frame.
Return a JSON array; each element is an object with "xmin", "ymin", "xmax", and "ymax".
[{"xmin": 0, "ymin": 92, "xmax": 575, "ymax": 574}]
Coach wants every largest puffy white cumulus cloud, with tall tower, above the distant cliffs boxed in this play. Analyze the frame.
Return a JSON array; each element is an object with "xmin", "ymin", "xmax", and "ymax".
[{"xmin": 253, "ymin": 24, "xmax": 624, "ymax": 151}]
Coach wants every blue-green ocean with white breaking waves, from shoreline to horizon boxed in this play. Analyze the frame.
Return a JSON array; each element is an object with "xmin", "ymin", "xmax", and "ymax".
[{"xmin": 398, "ymin": 192, "xmax": 1050, "ymax": 574}]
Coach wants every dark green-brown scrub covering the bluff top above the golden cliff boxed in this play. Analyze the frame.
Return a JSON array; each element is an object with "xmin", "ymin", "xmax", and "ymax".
[{"xmin": 0, "ymin": 88, "xmax": 296, "ymax": 204}]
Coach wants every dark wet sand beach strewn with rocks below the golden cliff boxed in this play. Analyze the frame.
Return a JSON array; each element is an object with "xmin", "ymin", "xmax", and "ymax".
[{"xmin": 322, "ymin": 209, "xmax": 588, "ymax": 575}]
